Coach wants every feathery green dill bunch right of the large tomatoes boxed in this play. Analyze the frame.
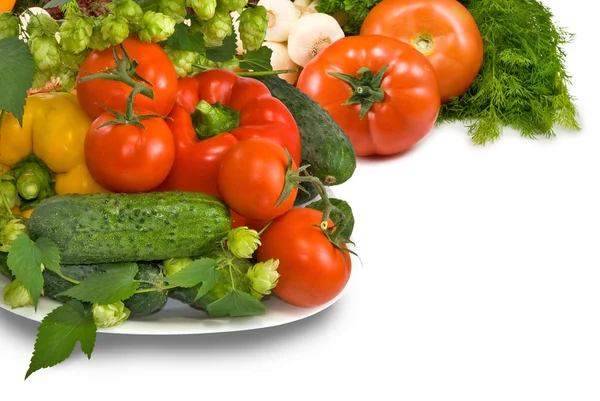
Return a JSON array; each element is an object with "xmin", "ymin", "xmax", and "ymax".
[{"xmin": 438, "ymin": 0, "xmax": 581, "ymax": 145}]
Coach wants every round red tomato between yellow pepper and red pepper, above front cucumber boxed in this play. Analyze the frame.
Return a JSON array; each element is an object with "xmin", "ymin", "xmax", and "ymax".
[{"xmin": 84, "ymin": 110, "xmax": 175, "ymax": 192}]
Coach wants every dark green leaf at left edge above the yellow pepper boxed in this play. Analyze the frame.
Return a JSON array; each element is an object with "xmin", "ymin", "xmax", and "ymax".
[{"xmin": 0, "ymin": 37, "xmax": 35, "ymax": 125}]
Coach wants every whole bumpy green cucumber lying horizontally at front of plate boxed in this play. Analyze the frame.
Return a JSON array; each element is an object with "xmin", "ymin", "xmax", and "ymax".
[{"xmin": 26, "ymin": 191, "xmax": 231, "ymax": 265}]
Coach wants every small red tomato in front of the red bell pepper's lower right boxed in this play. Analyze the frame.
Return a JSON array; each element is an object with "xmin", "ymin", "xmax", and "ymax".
[{"xmin": 217, "ymin": 138, "xmax": 298, "ymax": 221}]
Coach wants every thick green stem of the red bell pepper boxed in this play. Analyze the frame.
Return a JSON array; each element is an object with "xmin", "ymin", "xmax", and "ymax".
[{"xmin": 192, "ymin": 100, "xmax": 240, "ymax": 139}]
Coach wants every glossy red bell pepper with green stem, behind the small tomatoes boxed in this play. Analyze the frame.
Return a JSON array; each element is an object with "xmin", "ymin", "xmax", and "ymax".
[{"xmin": 157, "ymin": 69, "xmax": 301, "ymax": 196}]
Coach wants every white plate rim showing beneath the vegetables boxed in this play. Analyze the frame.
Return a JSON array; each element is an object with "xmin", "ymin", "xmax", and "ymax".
[{"xmin": 0, "ymin": 249, "xmax": 361, "ymax": 335}]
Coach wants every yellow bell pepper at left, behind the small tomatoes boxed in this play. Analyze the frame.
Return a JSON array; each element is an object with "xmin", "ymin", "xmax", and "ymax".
[{"xmin": 0, "ymin": 92, "xmax": 108, "ymax": 210}]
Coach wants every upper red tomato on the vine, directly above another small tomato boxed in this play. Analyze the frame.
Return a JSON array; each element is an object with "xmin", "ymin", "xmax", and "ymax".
[{"xmin": 76, "ymin": 37, "xmax": 177, "ymax": 119}]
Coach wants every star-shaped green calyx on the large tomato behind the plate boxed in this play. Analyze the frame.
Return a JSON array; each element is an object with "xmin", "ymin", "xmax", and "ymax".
[{"xmin": 328, "ymin": 64, "xmax": 388, "ymax": 119}]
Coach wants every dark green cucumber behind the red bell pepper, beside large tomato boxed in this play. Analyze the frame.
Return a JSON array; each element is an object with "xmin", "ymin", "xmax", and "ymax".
[{"xmin": 255, "ymin": 75, "xmax": 356, "ymax": 186}]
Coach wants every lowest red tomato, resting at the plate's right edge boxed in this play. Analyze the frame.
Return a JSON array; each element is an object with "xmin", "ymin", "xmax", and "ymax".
[{"xmin": 256, "ymin": 208, "xmax": 352, "ymax": 307}]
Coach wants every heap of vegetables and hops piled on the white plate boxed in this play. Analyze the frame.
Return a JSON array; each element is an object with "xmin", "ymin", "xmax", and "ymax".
[{"xmin": 0, "ymin": 0, "xmax": 356, "ymax": 378}]
